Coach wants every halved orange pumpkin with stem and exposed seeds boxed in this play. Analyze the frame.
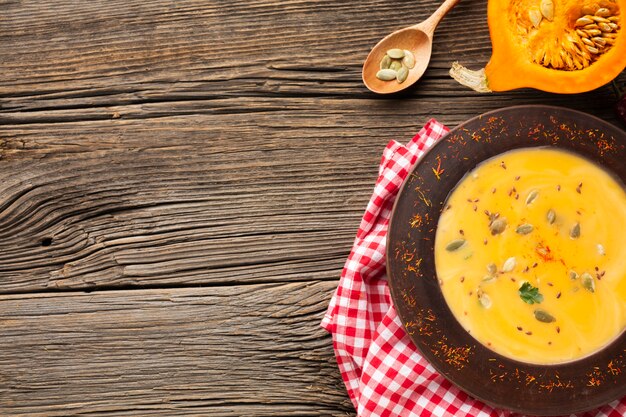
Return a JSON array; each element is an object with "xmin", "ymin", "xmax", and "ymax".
[{"xmin": 450, "ymin": 0, "xmax": 626, "ymax": 93}]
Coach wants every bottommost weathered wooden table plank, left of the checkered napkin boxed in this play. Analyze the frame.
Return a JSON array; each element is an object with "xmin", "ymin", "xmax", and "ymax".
[{"xmin": 0, "ymin": 282, "xmax": 352, "ymax": 417}]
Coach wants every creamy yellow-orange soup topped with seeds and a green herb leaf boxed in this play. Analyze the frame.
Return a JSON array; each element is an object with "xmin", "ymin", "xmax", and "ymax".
[{"xmin": 435, "ymin": 148, "xmax": 626, "ymax": 364}]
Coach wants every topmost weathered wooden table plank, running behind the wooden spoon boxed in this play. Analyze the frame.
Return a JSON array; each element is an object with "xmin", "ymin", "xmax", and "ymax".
[{"xmin": 0, "ymin": 0, "xmax": 490, "ymax": 105}]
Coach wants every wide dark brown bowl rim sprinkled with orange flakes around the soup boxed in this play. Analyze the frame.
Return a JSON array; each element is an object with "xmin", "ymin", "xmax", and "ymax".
[{"xmin": 387, "ymin": 106, "xmax": 626, "ymax": 415}]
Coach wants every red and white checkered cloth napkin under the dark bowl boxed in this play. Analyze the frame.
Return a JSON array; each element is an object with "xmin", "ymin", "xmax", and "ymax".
[{"xmin": 322, "ymin": 120, "xmax": 626, "ymax": 417}]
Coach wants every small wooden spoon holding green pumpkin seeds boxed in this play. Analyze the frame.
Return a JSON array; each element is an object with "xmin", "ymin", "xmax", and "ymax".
[{"xmin": 363, "ymin": 0, "xmax": 459, "ymax": 94}]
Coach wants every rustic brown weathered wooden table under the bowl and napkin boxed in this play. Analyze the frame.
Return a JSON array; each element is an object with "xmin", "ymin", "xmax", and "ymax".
[{"xmin": 0, "ymin": 0, "xmax": 623, "ymax": 416}]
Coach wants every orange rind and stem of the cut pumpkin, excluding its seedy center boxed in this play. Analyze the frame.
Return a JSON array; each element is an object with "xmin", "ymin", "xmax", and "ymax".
[{"xmin": 451, "ymin": 0, "xmax": 626, "ymax": 94}]
